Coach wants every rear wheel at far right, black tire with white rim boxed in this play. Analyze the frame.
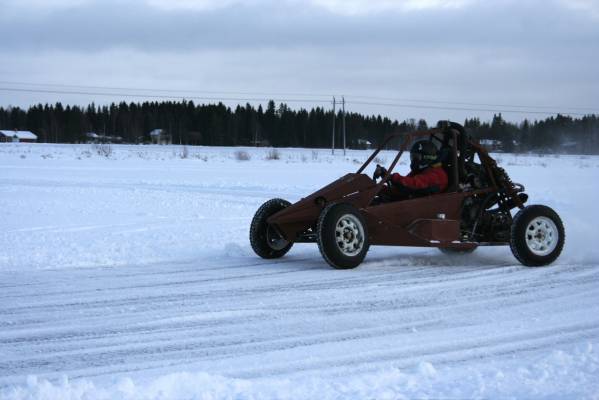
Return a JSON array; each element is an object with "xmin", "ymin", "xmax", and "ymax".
[{"xmin": 510, "ymin": 205, "xmax": 566, "ymax": 267}]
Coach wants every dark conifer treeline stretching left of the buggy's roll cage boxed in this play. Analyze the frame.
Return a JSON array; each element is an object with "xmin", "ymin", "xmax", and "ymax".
[{"xmin": 0, "ymin": 101, "xmax": 401, "ymax": 147}]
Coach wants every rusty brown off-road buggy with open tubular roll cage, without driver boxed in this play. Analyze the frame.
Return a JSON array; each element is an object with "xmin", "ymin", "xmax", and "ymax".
[{"xmin": 250, "ymin": 122, "xmax": 565, "ymax": 269}]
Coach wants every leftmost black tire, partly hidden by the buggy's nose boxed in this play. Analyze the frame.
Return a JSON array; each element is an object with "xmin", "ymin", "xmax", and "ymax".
[{"xmin": 250, "ymin": 199, "xmax": 293, "ymax": 259}]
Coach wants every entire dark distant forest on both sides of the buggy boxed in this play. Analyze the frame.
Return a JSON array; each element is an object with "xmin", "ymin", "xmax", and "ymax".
[{"xmin": 0, "ymin": 101, "xmax": 599, "ymax": 154}]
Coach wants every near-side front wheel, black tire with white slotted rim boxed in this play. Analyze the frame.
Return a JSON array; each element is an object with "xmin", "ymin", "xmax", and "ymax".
[{"xmin": 316, "ymin": 203, "xmax": 370, "ymax": 269}]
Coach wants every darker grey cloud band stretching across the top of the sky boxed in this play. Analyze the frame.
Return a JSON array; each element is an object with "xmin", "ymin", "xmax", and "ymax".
[{"xmin": 0, "ymin": 0, "xmax": 599, "ymax": 52}]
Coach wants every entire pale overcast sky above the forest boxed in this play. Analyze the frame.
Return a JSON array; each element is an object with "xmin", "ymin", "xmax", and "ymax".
[{"xmin": 0, "ymin": 0, "xmax": 599, "ymax": 122}]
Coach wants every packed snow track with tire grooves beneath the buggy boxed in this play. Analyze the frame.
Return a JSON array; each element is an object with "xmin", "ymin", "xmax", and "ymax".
[{"xmin": 0, "ymin": 253, "xmax": 599, "ymax": 384}]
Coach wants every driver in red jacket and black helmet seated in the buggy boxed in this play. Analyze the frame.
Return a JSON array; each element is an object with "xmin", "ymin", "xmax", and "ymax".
[{"xmin": 375, "ymin": 140, "xmax": 448, "ymax": 200}]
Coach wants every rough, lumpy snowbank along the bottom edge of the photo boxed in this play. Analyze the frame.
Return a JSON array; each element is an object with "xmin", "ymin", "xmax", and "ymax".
[{"xmin": 0, "ymin": 343, "xmax": 599, "ymax": 400}]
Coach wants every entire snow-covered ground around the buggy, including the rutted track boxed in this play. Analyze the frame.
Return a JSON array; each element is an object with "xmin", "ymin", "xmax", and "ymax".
[{"xmin": 0, "ymin": 144, "xmax": 599, "ymax": 399}]
